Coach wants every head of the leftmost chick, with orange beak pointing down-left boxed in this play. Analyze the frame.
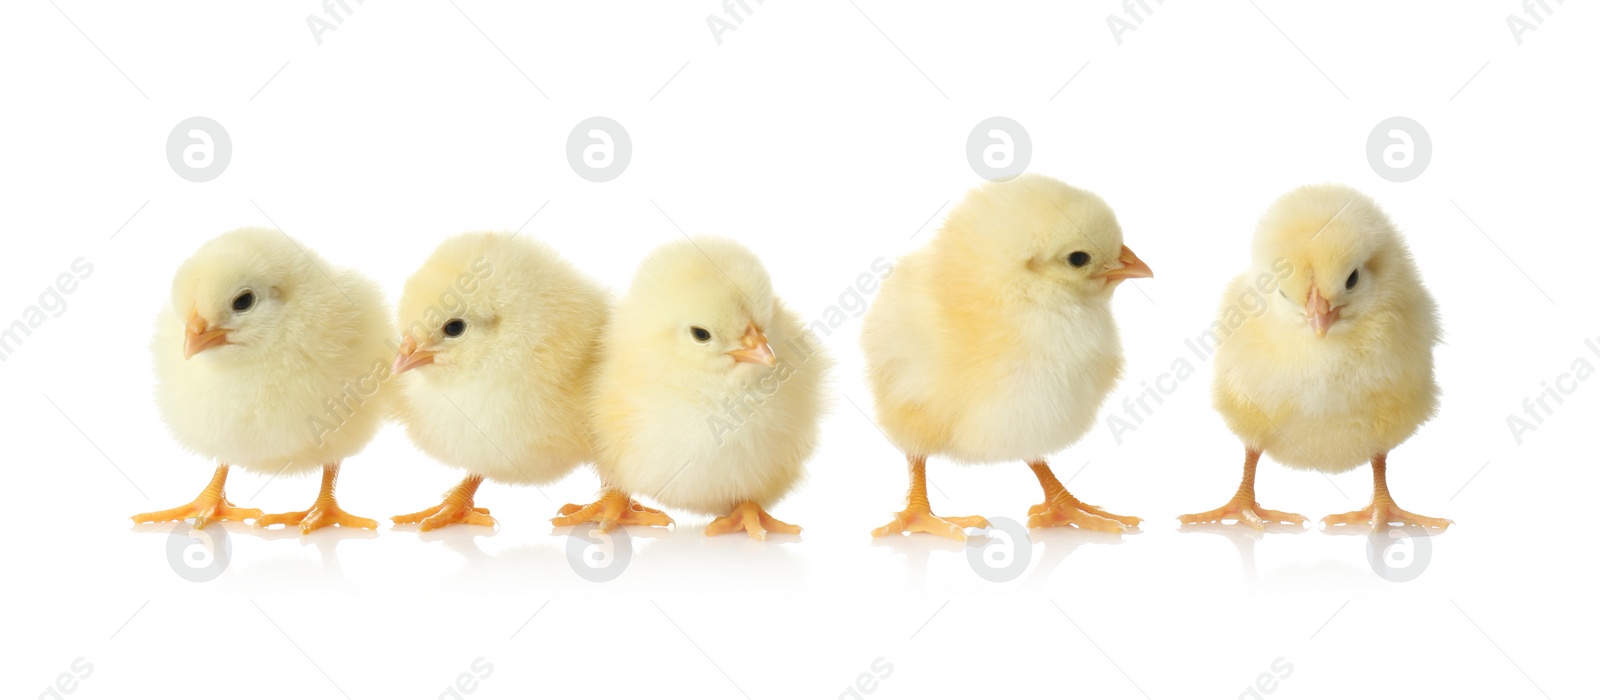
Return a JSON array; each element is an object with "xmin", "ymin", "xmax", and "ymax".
[{"xmin": 171, "ymin": 229, "xmax": 326, "ymax": 363}]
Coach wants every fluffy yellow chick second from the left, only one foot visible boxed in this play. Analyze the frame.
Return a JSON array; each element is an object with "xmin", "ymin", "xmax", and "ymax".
[{"xmin": 394, "ymin": 233, "xmax": 610, "ymax": 531}]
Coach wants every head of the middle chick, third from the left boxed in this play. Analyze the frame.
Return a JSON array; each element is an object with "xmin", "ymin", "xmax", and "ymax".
[{"xmin": 616, "ymin": 237, "xmax": 778, "ymax": 376}]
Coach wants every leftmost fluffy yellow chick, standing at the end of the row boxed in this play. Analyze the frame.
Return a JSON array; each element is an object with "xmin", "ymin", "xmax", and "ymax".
[{"xmin": 133, "ymin": 229, "xmax": 392, "ymax": 532}]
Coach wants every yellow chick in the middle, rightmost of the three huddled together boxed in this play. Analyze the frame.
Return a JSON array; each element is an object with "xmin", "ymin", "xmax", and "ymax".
[{"xmin": 554, "ymin": 237, "xmax": 832, "ymax": 540}]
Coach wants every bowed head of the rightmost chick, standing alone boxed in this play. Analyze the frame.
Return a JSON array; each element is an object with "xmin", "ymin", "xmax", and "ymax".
[{"xmin": 1254, "ymin": 184, "xmax": 1418, "ymax": 337}]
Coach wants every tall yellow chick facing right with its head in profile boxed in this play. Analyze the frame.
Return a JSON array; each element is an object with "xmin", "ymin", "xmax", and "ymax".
[{"xmin": 861, "ymin": 174, "xmax": 1150, "ymax": 540}]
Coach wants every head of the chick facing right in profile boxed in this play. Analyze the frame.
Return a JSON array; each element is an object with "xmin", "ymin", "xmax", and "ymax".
[{"xmin": 934, "ymin": 173, "xmax": 1152, "ymax": 305}]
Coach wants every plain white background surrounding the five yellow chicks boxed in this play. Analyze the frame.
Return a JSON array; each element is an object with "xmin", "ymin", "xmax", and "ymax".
[{"xmin": 0, "ymin": 0, "xmax": 1600, "ymax": 698}]
